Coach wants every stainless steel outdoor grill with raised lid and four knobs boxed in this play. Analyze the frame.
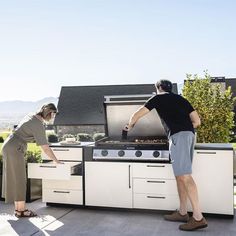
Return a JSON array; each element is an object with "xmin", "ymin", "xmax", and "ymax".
[{"xmin": 93, "ymin": 94, "xmax": 170, "ymax": 162}]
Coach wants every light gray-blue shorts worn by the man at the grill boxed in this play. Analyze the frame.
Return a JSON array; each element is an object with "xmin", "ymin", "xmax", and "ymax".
[{"xmin": 169, "ymin": 131, "xmax": 195, "ymax": 176}]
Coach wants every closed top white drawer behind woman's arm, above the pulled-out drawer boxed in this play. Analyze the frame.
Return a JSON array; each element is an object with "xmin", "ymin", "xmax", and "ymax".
[{"xmin": 42, "ymin": 147, "xmax": 83, "ymax": 161}]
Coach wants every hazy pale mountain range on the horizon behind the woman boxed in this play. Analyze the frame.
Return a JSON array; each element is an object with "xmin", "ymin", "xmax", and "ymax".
[{"xmin": 0, "ymin": 97, "xmax": 58, "ymax": 115}]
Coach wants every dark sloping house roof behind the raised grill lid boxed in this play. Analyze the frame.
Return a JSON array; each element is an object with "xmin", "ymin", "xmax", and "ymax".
[{"xmin": 54, "ymin": 84, "xmax": 177, "ymax": 126}]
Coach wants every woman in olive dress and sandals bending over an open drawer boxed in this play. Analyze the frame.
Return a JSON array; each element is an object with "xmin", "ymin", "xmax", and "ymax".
[{"xmin": 2, "ymin": 103, "xmax": 60, "ymax": 217}]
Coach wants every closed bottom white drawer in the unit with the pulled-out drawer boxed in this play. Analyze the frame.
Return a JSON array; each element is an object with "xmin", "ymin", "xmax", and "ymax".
[{"xmin": 43, "ymin": 188, "xmax": 83, "ymax": 205}]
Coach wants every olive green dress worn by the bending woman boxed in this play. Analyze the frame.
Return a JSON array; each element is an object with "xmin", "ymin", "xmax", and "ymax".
[{"xmin": 2, "ymin": 114, "xmax": 48, "ymax": 203}]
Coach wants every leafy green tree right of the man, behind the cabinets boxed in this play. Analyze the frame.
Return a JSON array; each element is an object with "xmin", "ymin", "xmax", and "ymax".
[{"xmin": 183, "ymin": 72, "xmax": 235, "ymax": 143}]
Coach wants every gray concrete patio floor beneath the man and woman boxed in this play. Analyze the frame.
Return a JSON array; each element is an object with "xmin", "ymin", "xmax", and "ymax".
[{"xmin": 0, "ymin": 199, "xmax": 236, "ymax": 236}]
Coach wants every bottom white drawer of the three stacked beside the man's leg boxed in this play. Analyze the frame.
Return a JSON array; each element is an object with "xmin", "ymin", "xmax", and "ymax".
[{"xmin": 133, "ymin": 194, "xmax": 179, "ymax": 210}]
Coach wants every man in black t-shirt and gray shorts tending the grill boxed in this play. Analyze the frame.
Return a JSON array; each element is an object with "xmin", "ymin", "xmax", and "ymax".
[{"xmin": 124, "ymin": 80, "xmax": 207, "ymax": 231}]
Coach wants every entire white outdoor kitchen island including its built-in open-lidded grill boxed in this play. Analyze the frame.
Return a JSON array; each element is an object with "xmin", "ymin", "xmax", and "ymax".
[{"xmin": 28, "ymin": 94, "xmax": 234, "ymax": 216}]
